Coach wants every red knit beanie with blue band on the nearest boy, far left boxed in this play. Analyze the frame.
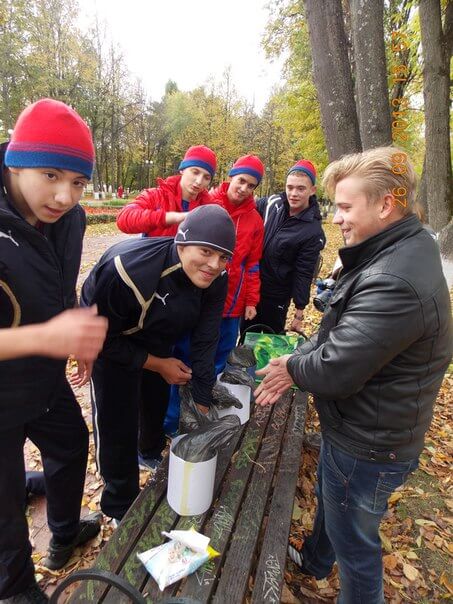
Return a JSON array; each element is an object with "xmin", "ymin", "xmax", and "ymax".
[{"xmin": 5, "ymin": 99, "xmax": 94, "ymax": 178}]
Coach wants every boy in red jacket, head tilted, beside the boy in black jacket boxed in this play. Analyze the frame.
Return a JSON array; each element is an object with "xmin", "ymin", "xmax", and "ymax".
[{"xmin": 210, "ymin": 155, "xmax": 264, "ymax": 371}]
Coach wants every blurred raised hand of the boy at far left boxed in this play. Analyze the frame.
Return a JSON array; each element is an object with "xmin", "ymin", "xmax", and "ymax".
[{"xmin": 36, "ymin": 306, "xmax": 108, "ymax": 362}]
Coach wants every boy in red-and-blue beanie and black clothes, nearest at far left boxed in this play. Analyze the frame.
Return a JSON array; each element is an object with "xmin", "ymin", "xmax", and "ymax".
[{"xmin": 0, "ymin": 99, "xmax": 105, "ymax": 604}]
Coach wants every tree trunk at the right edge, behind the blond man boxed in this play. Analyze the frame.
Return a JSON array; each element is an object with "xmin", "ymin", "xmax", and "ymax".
[{"xmin": 419, "ymin": 0, "xmax": 453, "ymax": 231}]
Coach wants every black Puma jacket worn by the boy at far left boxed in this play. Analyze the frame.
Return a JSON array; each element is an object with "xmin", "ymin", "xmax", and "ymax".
[{"xmin": 0, "ymin": 146, "xmax": 85, "ymax": 429}]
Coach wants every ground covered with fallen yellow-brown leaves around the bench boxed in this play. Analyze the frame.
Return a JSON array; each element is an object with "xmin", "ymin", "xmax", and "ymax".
[{"xmin": 26, "ymin": 224, "xmax": 453, "ymax": 604}]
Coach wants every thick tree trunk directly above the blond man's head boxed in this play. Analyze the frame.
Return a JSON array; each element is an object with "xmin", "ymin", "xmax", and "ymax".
[{"xmin": 305, "ymin": 0, "xmax": 362, "ymax": 161}]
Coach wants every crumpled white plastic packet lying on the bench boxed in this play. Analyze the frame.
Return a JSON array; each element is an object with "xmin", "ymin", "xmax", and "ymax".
[{"xmin": 137, "ymin": 528, "xmax": 220, "ymax": 591}]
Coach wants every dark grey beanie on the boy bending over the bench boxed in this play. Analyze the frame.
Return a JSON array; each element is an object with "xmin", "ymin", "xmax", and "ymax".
[{"xmin": 175, "ymin": 204, "xmax": 236, "ymax": 256}]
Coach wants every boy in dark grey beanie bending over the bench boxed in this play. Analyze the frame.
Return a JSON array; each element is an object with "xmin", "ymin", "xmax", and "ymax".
[{"xmin": 81, "ymin": 205, "xmax": 236, "ymax": 520}]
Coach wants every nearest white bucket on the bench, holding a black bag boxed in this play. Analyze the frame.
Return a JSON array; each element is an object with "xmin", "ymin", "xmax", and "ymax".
[{"xmin": 167, "ymin": 434, "xmax": 217, "ymax": 516}]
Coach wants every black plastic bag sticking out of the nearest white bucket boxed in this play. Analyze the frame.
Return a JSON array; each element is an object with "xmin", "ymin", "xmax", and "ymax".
[{"xmin": 173, "ymin": 415, "xmax": 241, "ymax": 463}]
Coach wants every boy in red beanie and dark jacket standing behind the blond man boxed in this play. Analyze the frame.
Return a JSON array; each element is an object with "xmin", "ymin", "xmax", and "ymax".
[{"xmin": 243, "ymin": 159, "xmax": 326, "ymax": 333}]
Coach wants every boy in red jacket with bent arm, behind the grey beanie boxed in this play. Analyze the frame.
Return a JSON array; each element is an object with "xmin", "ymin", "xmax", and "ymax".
[{"xmin": 116, "ymin": 145, "xmax": 217, "ymax": 237}]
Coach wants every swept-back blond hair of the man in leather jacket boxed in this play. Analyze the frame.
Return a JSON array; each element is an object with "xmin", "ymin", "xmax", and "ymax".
[{"xmin": 322, "ymin": 147, "xmax": 417, "ymax": 215}]
